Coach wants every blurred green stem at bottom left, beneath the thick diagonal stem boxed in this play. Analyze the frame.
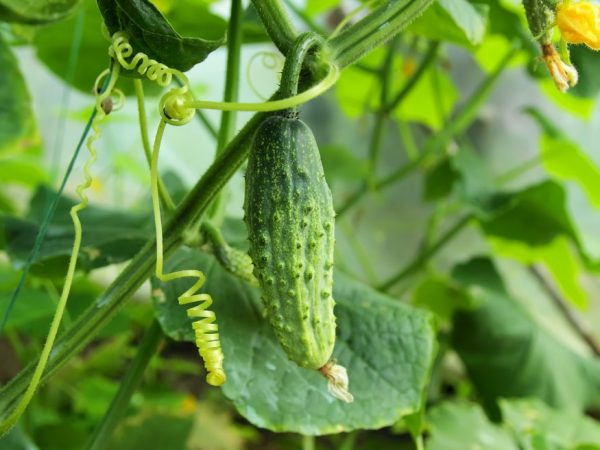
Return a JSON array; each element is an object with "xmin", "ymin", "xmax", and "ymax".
[{"xmin": 87, "ymin": 319, "xmax": 163, "ymax": 450}]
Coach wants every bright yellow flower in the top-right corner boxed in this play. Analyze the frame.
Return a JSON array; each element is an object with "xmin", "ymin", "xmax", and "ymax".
[{"xmin": 556, "ymin": 0, "xmax": 600, "ymax": 50}]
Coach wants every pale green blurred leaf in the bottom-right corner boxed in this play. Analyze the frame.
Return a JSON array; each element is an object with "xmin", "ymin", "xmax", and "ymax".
[{"xmin": 500, "ymin": 399, "xmax": 600, "ymax": 449}]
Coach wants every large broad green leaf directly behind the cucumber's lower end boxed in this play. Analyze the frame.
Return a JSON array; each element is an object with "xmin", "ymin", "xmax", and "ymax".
[{"xmin": 153, "ymin": 249, "xmax": 435, "ymax": 434}]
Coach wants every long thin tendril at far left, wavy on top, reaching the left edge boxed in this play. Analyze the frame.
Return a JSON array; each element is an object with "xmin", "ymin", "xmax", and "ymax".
[{"xmin": 0, "ymin": 64, "xmax": 123, "ymax": 435}]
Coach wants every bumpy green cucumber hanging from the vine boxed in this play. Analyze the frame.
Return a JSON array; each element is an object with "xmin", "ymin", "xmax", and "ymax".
[{"xmin": 244, "ymin": 115, "xmax": 335, "ymax": 369}]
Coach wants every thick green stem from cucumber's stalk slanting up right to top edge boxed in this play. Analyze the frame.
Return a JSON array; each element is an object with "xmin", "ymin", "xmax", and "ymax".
[{"xmin": 329, "ymin": 0, "xmax": 433, "ymax": 67}]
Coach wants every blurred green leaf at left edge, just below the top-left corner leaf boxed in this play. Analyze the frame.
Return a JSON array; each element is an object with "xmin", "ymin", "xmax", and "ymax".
[{"xmin": 0, "ymin": 35, "xmax": 40, "ymax": 156}]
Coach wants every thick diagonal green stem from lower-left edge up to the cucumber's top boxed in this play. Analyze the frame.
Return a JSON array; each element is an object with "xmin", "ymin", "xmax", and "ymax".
[{"xmin": 0, "ymin": 33, "xmax": 332, "ymax": 428}]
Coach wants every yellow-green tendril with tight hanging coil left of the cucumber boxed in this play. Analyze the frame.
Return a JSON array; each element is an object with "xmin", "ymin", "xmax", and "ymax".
[{"xmin": 150, "ymin": 120, "xmax": 226, "ymax": 386}]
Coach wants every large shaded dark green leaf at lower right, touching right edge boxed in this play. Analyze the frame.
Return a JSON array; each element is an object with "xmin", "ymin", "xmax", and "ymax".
[{"xmin": 452, "ymin": 258, "xmax": 600, "ymax": 410}]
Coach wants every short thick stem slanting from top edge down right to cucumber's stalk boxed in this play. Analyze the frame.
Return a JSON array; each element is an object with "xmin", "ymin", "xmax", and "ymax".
[{"xmin": 252, "ymin": 0, "xmax": 298, "ymax": 56}]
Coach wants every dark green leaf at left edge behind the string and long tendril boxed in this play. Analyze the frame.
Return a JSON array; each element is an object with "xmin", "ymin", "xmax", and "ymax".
[{"xmin": 0, "ymin": 188, "xmax": 152, "ymax": 276}]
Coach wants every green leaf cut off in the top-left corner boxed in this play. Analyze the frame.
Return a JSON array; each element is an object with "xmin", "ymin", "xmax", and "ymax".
[{"xmin": 0, "ymin": 0, "xmax": 79, "ymax": 24}]
